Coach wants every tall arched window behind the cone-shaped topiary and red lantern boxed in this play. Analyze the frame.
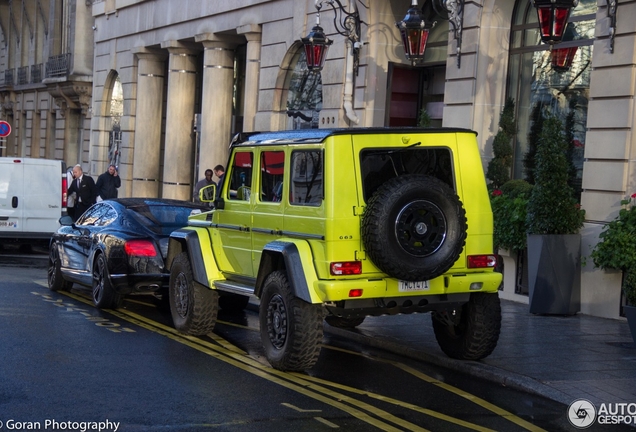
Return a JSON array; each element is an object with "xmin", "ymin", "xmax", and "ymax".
[{"xmin": 507, "ymin": 0, "xmax": 597, "ymax": 189}]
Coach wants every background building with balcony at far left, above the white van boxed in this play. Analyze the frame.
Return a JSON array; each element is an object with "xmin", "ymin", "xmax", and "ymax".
[{"xmin": 0, "ymin": 0, "xmax": 93, "ymax": 166}]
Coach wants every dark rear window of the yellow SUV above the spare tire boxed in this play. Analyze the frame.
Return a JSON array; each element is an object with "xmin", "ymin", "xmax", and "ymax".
[{"xmin": 360, "ymin": 147, "xmax": 455, "ymax": 201}]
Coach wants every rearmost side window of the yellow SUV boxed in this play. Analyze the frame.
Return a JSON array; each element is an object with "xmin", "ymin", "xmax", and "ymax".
[{"xmin": 289, "ymin": 150, "xmax": 324, "ymax": 207}]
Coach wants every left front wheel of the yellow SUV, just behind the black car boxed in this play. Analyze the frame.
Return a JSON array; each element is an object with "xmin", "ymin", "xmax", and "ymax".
[{"xmin": 168, "ymin": 252, "xmax": 219, "ymax": 336}]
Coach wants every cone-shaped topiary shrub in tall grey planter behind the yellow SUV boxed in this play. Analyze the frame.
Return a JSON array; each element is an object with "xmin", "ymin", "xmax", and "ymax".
[{"xmin": 527, "ymin": 115, "xmax": 585, "ymax": 315}]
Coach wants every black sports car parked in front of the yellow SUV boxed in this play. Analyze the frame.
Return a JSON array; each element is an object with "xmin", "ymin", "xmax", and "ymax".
[{"xmin": 48, "ymin": 198, "xmax": 210, "ymax": 308}]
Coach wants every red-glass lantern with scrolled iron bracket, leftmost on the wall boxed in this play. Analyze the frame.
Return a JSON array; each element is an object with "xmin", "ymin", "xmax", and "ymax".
[{"xmin": 300, "ymin": 0, "xmax": 362, "ymax": 75}]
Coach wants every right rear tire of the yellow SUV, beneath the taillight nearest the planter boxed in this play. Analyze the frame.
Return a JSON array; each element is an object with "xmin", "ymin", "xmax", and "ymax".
[{"xmin": 431, "ymin": 293, "xmax": 501, "ymax": 360}]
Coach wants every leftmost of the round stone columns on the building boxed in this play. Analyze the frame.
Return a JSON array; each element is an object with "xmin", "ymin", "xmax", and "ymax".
[{"xmin": 132, "ymin": 47, "xmax": 166, "ymax": 198}]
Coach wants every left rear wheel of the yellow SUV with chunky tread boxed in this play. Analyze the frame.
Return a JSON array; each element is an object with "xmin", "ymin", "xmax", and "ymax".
[{"xmin": 259, "ymin": 271, "xmax": 323, "ymax": 371}]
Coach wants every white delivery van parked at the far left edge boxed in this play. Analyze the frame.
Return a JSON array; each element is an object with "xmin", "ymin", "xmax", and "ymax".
[{"xmin": 0, "ymin": 157, "xmax": 67, "ymax": 241}]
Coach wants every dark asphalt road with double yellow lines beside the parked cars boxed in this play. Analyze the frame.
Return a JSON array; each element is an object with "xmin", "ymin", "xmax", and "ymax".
[{"xmin": 0, "ymin": 246, "xmax": 617, "ymax": 431}]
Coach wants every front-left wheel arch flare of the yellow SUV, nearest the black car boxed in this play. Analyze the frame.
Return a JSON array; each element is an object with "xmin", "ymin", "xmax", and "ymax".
[{"xmin": 166, "ymin": 228, "xmax": 220, "ymax": 287}]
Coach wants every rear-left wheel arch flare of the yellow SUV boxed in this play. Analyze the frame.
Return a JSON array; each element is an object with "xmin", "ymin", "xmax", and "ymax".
[{"xmin": 254, "ymin": 240, "xmax": 322, "ymax": 303}]
